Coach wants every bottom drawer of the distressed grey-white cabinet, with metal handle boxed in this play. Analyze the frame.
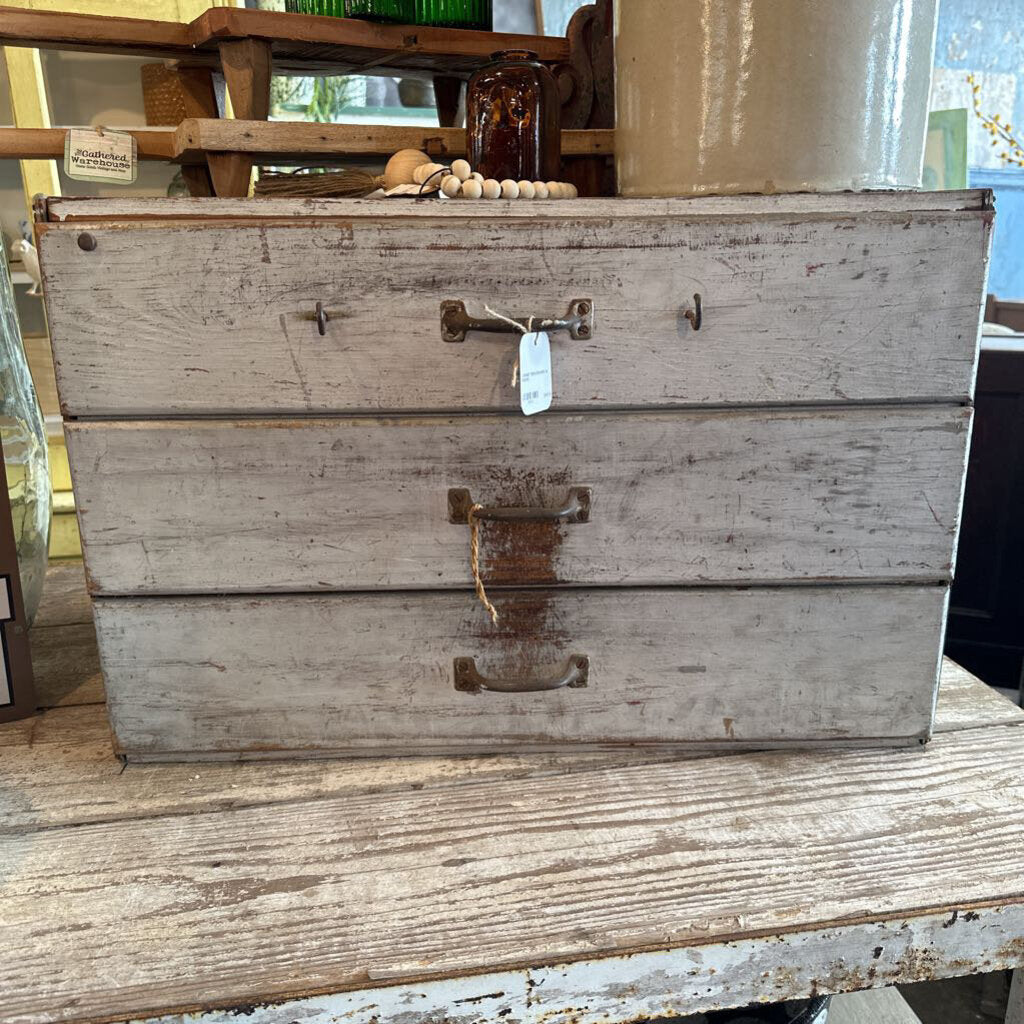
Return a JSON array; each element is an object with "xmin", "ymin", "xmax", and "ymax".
[{"xmin": 95, "ymin": 586, "xmax": 946, "ymax": 760}]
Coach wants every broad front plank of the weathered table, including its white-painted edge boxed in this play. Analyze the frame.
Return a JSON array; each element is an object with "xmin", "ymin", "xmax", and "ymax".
[{"xmin": 0, "ymin": 728, "xmax": 1024, "ymax": 1024}]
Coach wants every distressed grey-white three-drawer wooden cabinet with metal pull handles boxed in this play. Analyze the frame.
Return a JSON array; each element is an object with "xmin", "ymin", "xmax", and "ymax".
[{"xmin": 39, "ymin": 191, "xmax": 992, "ymax": 759}]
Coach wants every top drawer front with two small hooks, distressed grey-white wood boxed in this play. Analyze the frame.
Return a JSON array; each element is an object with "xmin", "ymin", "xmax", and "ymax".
[{"xmin": 40, "ymin": 211, "xmax": 989, "ymax": 416}]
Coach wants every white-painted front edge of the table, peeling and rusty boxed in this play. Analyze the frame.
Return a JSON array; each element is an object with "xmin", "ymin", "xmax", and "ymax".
[{"xmin": 121, "ymin": 903, "xmax": 1024, "ymax": 1024}]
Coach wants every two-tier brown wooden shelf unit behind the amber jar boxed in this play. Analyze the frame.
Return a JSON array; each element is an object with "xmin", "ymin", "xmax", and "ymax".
[{"xmin": 0, "ymin": 0, "xmax": 614, "ymax": 197}]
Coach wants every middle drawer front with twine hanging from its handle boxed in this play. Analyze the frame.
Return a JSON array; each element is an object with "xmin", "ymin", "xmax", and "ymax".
[{"xmin": 68, "ymin": 406, "xmax": 970, "ymax": 594}]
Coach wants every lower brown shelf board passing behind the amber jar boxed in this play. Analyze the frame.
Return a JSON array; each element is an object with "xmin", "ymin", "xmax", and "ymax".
[{"xmin": 174, "ymin": 118, "xmax": 614, "ymax": 163}]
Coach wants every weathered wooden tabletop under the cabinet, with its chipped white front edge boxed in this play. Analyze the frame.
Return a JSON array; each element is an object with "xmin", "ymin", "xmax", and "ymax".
[{"xmin": 0, "ymin": 564, "xmax": 1024, "ymax": 1024}]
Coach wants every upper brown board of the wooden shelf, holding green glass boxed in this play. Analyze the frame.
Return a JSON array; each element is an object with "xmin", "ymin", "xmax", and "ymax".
[{"xmin": 0, "ymin": 7, "xmax": 569, "ymax": 77}]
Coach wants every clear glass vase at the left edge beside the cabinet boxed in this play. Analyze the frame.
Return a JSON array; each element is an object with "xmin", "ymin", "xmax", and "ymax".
[{"xmin": 0, "ymin": 244, "xmax": 53, "ymax": 626}]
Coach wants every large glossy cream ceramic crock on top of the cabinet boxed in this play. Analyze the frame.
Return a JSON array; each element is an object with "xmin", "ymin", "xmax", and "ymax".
[{"xmin": 615, "ymin": 0, "xmax": 938, "ymax": 196}]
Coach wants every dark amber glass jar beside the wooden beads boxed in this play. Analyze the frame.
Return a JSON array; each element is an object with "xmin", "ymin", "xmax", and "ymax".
[{"xmin": 466, "ymin": 50, "xmax": 562, "ymax": 181}]
